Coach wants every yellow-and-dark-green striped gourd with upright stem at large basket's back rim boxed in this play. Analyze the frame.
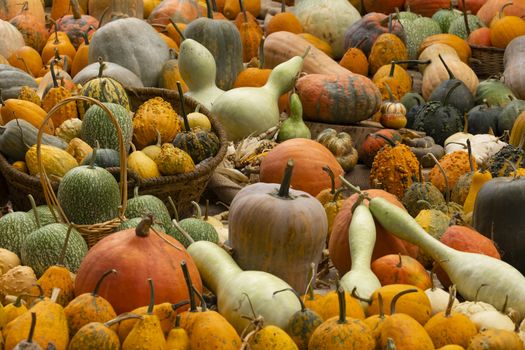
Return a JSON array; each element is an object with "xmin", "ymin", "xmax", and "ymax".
[{"xmin": 77, "ymin": 60, "xmax": 131, "ymax": 118}]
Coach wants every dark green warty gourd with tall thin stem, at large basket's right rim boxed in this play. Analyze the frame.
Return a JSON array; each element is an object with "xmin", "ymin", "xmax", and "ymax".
[{"xmin": 172, "ymin": 82, "xmax": 220, "ymax": 164}]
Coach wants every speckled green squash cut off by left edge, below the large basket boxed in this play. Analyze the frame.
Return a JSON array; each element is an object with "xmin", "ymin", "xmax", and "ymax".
[{"xmin": 0, "ymin": 211, "xmax": 37, "ymax": 256}]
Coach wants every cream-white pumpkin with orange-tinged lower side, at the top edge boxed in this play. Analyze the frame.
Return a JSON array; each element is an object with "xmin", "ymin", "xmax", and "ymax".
[{"xmin": 294, "ymin": 0, "xmax": 361, "ymax": 58}]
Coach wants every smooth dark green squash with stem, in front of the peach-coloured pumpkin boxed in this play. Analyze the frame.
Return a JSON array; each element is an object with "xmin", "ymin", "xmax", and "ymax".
[{"xmin": 428, "ymin": 55, "xmax": 474, "ymax": 115}]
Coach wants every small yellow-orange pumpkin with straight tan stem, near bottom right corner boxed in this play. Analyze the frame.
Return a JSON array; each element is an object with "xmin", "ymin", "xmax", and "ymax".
[{"xmin": 425, "ymin": 286, "xmax": 478, "ymax": 348}]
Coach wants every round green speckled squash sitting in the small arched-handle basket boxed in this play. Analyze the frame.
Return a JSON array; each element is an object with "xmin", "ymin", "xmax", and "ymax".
[{"xmin": 57, "ymin": 165, "xmax": 120, "ymax": 225}]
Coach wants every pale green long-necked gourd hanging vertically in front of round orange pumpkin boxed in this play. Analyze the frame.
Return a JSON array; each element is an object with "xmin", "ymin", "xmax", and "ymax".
[{"xmin": 340, "ymin": 204, "xmax": 381, "ymax": 311}]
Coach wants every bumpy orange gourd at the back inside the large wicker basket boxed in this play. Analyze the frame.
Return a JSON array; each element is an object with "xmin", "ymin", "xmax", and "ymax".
[{"xmin": 133, "ymin": 96, "xmax": 182, "ymax": 149}]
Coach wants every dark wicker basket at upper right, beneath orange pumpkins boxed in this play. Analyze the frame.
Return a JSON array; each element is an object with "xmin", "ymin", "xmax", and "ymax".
[{"xmin": 470, "ymin": 45, "xmax": 505, "ymax": 79}]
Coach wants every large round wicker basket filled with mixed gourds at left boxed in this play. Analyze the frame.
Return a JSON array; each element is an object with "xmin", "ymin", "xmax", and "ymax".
[{"xmin": 0, "ymin": 88, "xmax": 228, "ymax": 223}]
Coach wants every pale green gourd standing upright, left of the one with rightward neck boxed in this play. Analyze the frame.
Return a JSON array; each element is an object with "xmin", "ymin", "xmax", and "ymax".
[{"xmin": 179, "ymin": 39, "xmax": 224, "ymax": 110}]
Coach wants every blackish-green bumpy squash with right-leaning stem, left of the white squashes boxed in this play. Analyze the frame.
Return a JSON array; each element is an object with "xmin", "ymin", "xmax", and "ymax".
[{"xmin": 413, "ymin": 82, "xmax": 463, "ymax": 145}]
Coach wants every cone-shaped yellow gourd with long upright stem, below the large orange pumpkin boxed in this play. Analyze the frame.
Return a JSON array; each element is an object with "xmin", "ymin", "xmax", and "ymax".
[{"xmin": 122, "ymin": 278, "xmax": 166, "ymax": 350}]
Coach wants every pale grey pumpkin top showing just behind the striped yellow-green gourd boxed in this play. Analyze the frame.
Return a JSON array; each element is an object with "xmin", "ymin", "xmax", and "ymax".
[{"xmin": 73, "ymin": 62, "xmax": 144, "ymax": 88}]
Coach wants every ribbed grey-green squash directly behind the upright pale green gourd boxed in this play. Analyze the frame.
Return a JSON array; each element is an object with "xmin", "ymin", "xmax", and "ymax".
[{"xmin": 184, "ymin": 4, "xmax": 244, "ymax": 90}]
